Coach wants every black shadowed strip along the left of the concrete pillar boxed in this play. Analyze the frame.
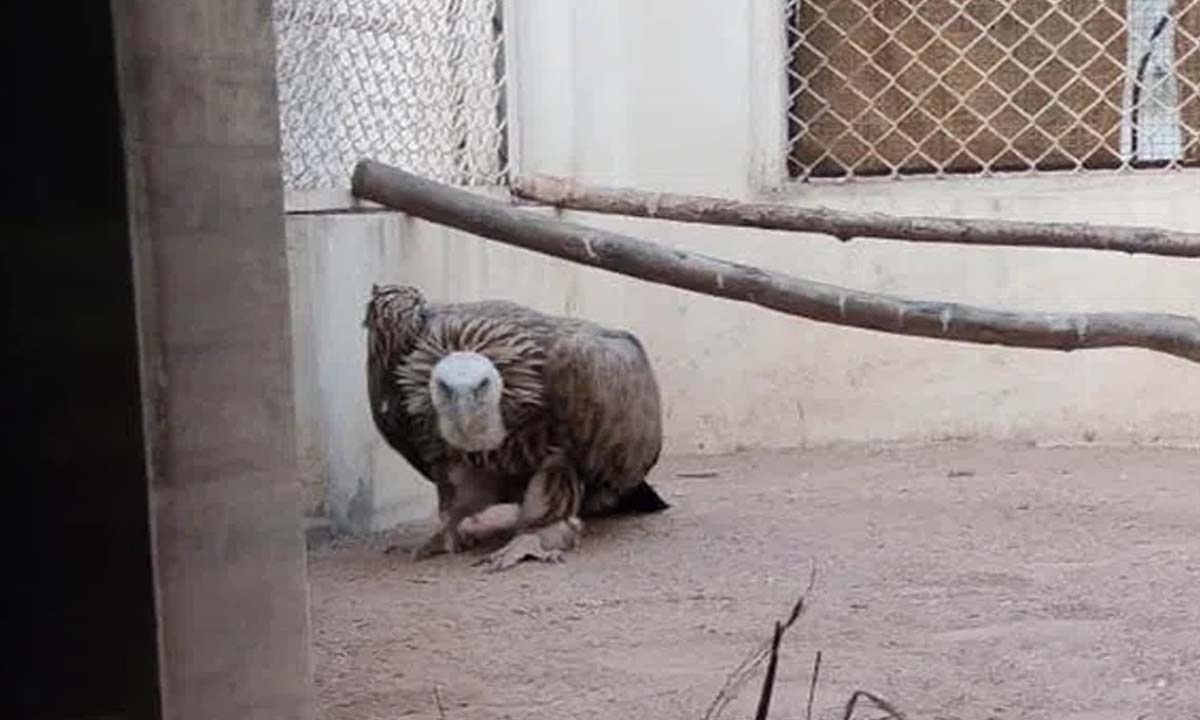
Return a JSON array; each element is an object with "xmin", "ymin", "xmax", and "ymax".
[{"xmin": 0, "ymin": 2, "xmax": 158, "ymax": 720}]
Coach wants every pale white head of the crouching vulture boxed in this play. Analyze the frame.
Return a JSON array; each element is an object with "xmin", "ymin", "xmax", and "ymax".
[{"xmin": 430, "ymin": 352, "xmax": 508, "ymax": 452}]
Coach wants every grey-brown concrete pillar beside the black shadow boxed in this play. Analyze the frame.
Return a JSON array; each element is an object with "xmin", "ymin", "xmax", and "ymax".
[{"xmin": 112, "ymin": 0, "xmax": 313, "ymax": 720}]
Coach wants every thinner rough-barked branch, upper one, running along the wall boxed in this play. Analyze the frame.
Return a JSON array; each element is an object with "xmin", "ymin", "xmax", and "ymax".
[{"xmin": 512, "ymin": 175, "xmax": 1200, "ymax": 258}]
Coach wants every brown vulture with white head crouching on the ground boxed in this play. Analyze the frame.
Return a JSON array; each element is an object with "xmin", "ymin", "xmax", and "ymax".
[{"xmin": 364, "ymin": 284, "xmax": 668, "ymax": 570}]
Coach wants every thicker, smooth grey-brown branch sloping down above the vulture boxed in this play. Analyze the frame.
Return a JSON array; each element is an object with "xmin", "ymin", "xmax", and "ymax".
[{"xmin": 352, "ymin": 161, "xmax": 1200, "ymax": 361}]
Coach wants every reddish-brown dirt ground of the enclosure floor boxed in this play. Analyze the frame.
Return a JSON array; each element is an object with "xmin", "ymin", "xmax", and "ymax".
[{"xmin": 310, "ymin": 444, "xmax": 1200, "ymax": 720}]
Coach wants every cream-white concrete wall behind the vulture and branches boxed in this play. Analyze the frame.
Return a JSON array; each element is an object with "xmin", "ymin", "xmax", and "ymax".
[{"xmin": 288, "ymin": 0, "xmax": 1200, "ymax": 528}]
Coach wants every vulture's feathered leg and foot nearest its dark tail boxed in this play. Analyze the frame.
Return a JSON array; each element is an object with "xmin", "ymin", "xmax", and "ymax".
[{"xmin": 479, "ymin": 455, "xmax": 583, "ymax": 572}]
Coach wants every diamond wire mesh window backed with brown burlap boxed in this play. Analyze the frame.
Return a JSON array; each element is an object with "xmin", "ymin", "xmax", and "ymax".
[{"xmin": 786, "ymin": 0, "xmax": 1200, "ymax": 179}]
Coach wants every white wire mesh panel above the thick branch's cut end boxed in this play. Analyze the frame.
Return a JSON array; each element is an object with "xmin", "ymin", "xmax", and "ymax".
[{"xmin": 275, "ymin": 0, "xmax": 508, "ymax": 190}]
